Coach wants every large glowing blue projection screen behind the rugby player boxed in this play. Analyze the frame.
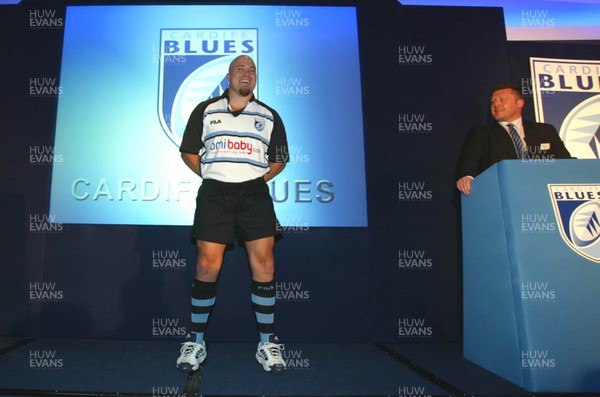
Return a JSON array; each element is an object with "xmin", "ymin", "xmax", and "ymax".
[{"xmin": 50, "ymin": 6, "xmax": 367, "ymax": 228}]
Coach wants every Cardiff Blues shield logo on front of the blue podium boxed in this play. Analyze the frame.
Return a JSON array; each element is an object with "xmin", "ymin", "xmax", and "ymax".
[{"xmin": 548, "ymin": 184, "xmax": 600, "ymax": 263}]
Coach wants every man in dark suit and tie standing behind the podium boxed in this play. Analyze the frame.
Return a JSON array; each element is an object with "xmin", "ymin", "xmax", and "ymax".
[{"xmin": 456, "ymin": 84, "xmax": 571, "ymax": 194}]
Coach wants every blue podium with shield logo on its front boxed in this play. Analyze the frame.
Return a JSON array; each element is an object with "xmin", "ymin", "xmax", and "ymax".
[{"xmin": 462, "ymin": 159, "xmax": 600, "ymax": 393}]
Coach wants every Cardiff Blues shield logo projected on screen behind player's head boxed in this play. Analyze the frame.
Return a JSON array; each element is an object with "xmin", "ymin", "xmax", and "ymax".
[{"xmin": 158, "ymin": 29, "xmax": 258, "ymax": 147}]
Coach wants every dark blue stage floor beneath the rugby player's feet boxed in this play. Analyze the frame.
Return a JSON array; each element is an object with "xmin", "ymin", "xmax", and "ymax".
[{"xmin": 0, "ymin": 338, "xmax": 591, "ymax": 397}]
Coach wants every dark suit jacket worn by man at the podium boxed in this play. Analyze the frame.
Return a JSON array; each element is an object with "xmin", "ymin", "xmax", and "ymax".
[{"xmin": 456, "ymin": 120, "xmax": 571, "ymax": 180}]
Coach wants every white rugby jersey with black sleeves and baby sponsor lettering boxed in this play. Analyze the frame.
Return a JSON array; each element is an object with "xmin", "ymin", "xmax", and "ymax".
[{"xmin": 179, "ymin": 91, "xmax": 289, "ymax": 182}]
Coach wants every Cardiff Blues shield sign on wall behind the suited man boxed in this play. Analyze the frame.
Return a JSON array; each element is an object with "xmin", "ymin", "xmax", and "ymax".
[{"xmin": 530, "ymin": 58, "xmax": 600, "ymax": 159}]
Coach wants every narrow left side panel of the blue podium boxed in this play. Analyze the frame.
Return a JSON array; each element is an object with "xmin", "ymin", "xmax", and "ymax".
[{"xmin": 462, "ymin": 167, "xmax": 523, "ymax": 384}]
